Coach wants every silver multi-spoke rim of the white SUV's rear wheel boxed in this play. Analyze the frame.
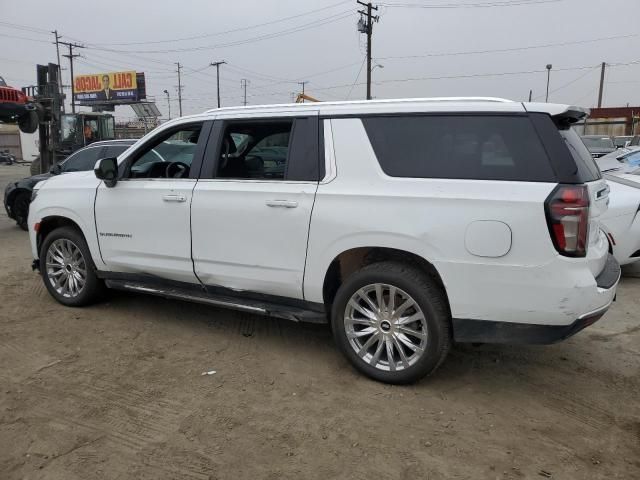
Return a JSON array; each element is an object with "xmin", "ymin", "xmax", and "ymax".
[{"xmin": 344, "ymin": 283, "xmax": 428, "ymax": 372}]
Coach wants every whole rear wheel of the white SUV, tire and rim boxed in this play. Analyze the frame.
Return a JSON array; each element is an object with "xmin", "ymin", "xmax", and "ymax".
[{"xmin": 331, "ymin": 262, "xmax": 451, "ymax": 384}]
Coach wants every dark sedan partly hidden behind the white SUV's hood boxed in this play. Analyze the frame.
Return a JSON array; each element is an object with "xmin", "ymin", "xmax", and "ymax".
[{"xmin": 4, "ymin": 140, "xmax": 136, "ymax": 230}]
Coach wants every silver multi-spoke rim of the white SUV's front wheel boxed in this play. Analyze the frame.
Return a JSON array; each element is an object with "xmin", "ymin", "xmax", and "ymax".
[{"xmin": 45, "ymin": 238, "xmax": 87, "ymax": 298}]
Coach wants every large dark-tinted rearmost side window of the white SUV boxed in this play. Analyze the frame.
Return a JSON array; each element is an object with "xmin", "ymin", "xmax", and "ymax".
[{"xmin": 362, "ymin": 115, "xmax": 556, "ymax": 182}]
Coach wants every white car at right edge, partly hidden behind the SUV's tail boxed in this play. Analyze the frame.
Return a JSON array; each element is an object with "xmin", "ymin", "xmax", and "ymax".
[{"xmin": 596, "ymin": 147, "xmax": 640, "ymax": 265}]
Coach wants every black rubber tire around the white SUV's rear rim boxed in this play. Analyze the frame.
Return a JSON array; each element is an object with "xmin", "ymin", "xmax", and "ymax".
[{"xmin": 331, "ymin": 262, "xmax": 452, "ymax": 384}]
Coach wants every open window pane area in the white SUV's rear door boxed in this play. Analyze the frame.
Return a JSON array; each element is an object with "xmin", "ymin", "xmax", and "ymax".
[{"xmin": 216, "ymin": 120, "xmax": 293, "ymax": 180}]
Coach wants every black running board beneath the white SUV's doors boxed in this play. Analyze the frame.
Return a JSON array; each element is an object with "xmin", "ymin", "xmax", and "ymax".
[{"xmin": 105, "ymin": 279, "xmax": 327, "ymax": 323}]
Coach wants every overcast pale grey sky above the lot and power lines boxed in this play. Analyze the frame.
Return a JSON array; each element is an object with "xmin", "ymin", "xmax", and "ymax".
[{"xmin": 0, "ymin": 0, "xmax": 640, "ymax": 117}]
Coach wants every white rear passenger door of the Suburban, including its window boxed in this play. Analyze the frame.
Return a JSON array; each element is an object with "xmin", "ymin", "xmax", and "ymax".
[{"xmin": 191, "ymin": 113, "xmax": 320, "ymax": 299}]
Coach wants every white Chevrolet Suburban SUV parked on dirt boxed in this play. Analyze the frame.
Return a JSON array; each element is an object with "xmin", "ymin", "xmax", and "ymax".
[{"xmin": 29, "ymin": 98, "xmax": 620, "ymax": 383}]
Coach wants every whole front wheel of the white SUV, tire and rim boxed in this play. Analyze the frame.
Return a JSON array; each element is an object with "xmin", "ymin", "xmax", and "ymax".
[{"xmin": 40, "ymin": 227, "xmax": 105, "ymax": 307}]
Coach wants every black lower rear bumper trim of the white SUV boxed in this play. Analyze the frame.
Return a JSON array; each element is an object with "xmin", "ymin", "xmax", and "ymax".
[{"xmin": 452, "ymin": 255, "xmax": 621, "ymax": 345}]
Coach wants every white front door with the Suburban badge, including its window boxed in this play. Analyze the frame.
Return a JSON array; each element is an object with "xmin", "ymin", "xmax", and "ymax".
[{"xmin": 95, "ymin": 122, "xmax": 211, "ymax": 283}]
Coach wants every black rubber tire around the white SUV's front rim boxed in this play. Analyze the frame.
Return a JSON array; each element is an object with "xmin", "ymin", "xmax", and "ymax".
[{"xmin": 40, "ymin": 227, "xmax": 105, "ymax": 307}]
